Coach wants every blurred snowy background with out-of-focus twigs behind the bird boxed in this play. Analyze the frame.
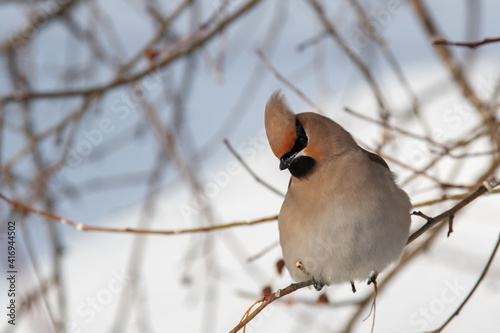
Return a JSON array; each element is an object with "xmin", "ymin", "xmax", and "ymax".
[{"xmin": 0, "ymin": 0, "xmax": 500, "ymax": 332}]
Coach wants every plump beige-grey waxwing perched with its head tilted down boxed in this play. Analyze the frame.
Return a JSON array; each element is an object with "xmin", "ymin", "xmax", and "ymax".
[{"xmin": 264, "ymin": 90, "xmax": 412, "ymax": 292}]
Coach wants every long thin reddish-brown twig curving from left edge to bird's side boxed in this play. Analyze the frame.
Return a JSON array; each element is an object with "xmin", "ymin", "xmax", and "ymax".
[{"xmin": 0, "ymin": 193, "xmax": 278, "ymax": 236}]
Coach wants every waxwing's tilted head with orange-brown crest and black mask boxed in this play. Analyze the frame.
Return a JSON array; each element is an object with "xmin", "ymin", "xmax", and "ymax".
[{"xmin": 264, "ymin": 91, "xmax": 357, "ymax": 178}]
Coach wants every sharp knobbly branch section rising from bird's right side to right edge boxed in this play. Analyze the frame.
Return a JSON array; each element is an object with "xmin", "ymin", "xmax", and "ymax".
[{"xmin": 407, "ymin": 179, "xmax": 500, "ymax": 244}]
